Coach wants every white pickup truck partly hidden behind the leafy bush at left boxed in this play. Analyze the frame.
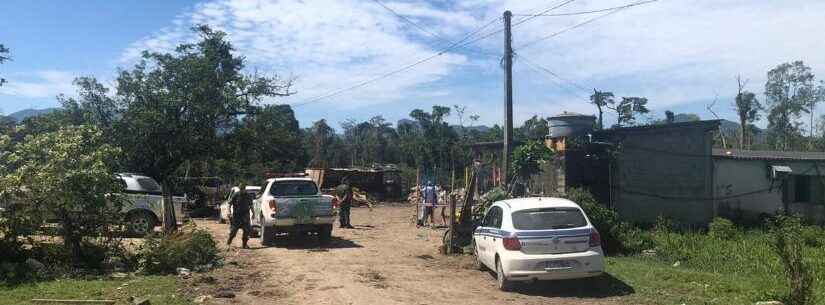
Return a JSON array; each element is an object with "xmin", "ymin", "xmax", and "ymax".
[{"xmin": 117, "ymin": 173, "xmax": 188, "ymax": 237}]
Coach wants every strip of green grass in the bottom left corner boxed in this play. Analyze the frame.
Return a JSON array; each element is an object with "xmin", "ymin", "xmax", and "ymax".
[{"xmin": 0, "ymin": 276, "xmax": 193, "ymax": 305}]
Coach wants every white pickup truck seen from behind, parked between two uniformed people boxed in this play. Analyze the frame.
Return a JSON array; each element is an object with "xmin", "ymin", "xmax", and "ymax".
[{"xmin": 252, "ymin": 178, "xmax": 336, "ymax": 245}]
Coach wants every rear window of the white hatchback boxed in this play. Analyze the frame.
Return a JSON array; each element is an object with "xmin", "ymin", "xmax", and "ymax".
[{"xmin": 513, "ymin": 208, "xmax": 587, "ymax": 230}]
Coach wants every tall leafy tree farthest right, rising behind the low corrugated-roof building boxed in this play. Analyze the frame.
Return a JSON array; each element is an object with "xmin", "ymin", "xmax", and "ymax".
[{"xmin": 765, "ymin": 61, "xmax": 817, "ymax": 150}]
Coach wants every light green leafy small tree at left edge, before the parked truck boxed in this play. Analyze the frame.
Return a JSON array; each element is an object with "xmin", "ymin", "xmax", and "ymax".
[{"xmin": 0, "ymin": 126, "xmax": 122, "ymax": 263}]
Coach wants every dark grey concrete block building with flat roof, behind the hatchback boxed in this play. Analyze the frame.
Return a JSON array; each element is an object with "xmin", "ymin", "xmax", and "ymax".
[{"xmin": 591, "ymin": 120, "xmax": 719, "ymax": 226}]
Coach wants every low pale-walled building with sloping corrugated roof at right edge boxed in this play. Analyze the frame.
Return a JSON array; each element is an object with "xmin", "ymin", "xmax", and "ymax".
[{"xmin": 713, "ymin": 149, "xmax": 825, "ymax": 224}]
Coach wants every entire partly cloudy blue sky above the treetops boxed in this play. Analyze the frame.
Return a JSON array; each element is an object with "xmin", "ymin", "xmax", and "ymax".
[{"xmin": 0, "ymin": 0, "xmax": 825, "ymax": 126}]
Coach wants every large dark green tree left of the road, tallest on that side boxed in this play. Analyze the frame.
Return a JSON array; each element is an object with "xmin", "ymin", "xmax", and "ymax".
[{"xmin": 115, "ymin": 26, "xmax": 291, "ymax": 229}]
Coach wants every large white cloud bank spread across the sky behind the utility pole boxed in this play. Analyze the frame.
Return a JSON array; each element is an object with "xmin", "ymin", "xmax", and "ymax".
[{"xmin": 117, "ymin": 0, "xmax": 825, "ymax": 123}]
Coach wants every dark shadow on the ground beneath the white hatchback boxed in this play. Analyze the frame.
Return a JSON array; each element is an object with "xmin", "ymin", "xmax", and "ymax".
[{"xmin": 506, "ymin": 273, "xmax": 636, "ymax": 298}]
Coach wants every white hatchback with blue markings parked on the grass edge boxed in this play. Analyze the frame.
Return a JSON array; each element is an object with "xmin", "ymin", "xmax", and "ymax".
[{"xmin": 473, "ymin": 197, "xmax": 604, "ymax": 290}]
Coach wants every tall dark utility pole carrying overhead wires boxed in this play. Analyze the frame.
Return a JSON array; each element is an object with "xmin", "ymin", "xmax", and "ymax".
[{"xmin": 501, "ymin": 11, "xmax": 513, "ymax": 187}]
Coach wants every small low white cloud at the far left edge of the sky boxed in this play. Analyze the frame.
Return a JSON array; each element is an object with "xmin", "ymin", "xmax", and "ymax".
[{"xmin": 0, "ymin": 70, "xmax": 76, "ymax": 98}]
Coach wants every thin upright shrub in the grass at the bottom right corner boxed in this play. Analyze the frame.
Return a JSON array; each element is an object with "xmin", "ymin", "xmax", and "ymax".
[{"xmin": 771, "ymin": 216, "xmax": 814, "ymax": 305}]
